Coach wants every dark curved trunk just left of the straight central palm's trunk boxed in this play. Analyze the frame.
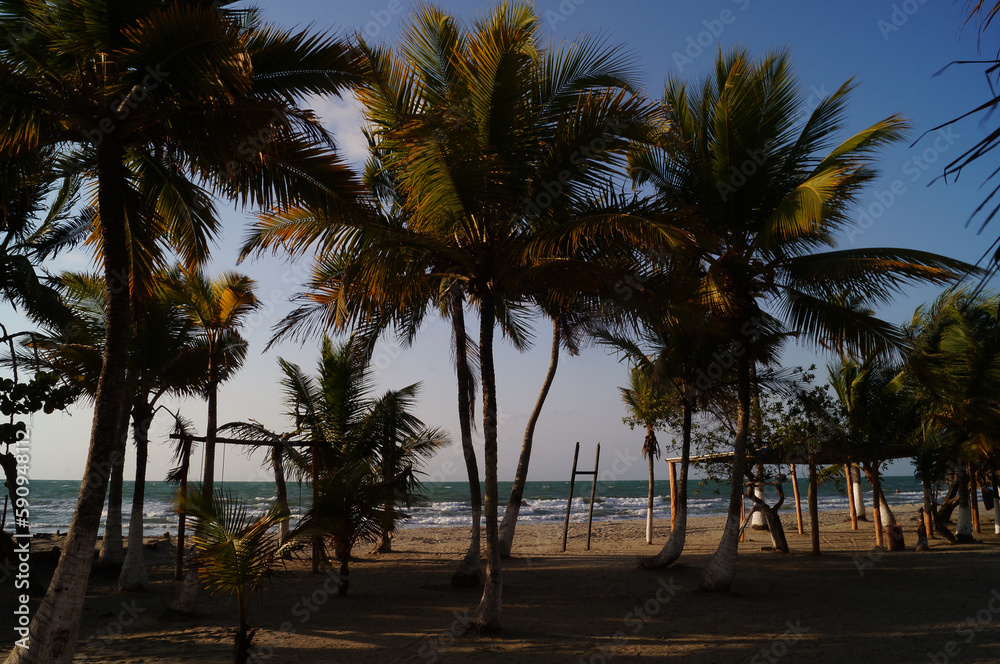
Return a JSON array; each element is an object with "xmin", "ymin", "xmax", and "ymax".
[{"xmin": 451, "ymin": 291, "xmax": 483, "ymax": 588}]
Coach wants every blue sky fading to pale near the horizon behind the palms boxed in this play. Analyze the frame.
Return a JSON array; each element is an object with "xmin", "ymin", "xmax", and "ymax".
[{"xmin": 2, "ymin": 0, "xmax": 1000, "ymax": 482}]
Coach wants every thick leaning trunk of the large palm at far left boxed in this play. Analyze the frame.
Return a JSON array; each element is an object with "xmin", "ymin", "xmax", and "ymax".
[{"xmin": 4, "ymin": 139, "xmax": 131, "ymax": 664}]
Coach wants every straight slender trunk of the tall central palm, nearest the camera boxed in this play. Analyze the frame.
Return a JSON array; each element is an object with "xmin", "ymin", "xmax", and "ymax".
[{"xmin": 474, "ymin": 293, "xmax": 503, "ymax": 634}]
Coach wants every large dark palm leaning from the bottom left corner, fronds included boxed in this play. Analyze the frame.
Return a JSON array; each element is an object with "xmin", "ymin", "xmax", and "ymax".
[{"xmin": 0, "ymin": 0, "xmax": 368, "ymax": 664}]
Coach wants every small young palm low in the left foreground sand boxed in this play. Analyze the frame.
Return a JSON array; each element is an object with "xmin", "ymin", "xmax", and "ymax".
[{"xmin": 178, "ymin": 492, "xmax": 299, "ymax": 664}]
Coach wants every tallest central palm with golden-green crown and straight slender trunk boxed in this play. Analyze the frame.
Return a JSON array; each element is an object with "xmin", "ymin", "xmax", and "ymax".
[{"xmin": 246, "ymin": 2, "xmax": 678, "ymax": 632}]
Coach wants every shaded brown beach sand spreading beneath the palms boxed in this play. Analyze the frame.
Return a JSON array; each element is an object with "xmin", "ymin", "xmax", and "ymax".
[{"xmin": 0, "ymin": 508, "xmax": 1000, "ymax": 664}]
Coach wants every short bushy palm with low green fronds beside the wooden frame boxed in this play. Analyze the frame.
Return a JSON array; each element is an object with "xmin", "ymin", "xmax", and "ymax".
[{"xmin": 279, "ymin": 337, "xmax": 448, "ymax": 594}]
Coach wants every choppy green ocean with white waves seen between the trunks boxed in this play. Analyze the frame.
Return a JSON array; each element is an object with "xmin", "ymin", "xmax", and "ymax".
[{"xmin": 9, "ymin": 476, "xmax": 923, "ymax": 536}]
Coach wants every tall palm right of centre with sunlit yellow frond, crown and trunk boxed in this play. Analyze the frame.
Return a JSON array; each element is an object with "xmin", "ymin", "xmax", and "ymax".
[{"xmin": 632, "ymin": 48, "xmax": 960, "ymax": 590}]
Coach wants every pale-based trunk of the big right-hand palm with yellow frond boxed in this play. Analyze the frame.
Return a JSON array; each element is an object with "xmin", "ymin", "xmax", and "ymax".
[{"xmin": 701, "ymin": 354, "xmax": 750, "ymax": 591}]
